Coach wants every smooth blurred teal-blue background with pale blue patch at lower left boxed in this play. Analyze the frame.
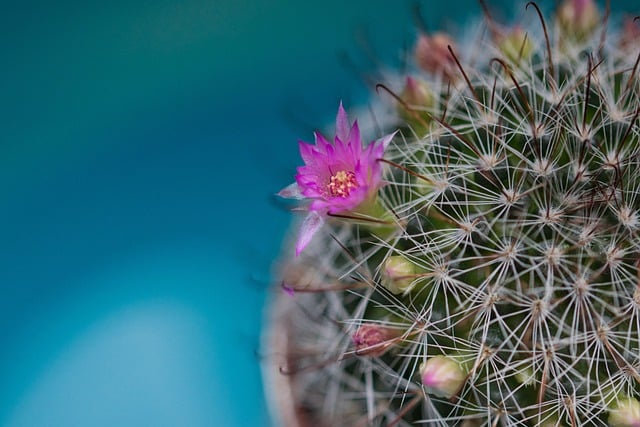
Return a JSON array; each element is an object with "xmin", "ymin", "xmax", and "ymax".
[{"xmin": 0, "ymin": 0, "xmax": 632, "ymax": 427}]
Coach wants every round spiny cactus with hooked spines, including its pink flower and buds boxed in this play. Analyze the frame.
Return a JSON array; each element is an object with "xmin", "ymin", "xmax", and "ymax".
[{"xmin": 267, "ymin": 0, "xmax": 640, "ymax": 427}]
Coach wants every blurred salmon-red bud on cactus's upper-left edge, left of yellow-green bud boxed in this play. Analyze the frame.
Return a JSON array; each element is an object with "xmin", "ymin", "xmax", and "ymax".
[{"xmin": 415, "ymin": 33, "xmax": 458, "ymax": 81}]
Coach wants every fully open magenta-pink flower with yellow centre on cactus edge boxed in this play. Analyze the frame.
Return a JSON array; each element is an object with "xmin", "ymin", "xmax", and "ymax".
[{"xmin": 278, "ymin": 103, "xmax": 393, "ymax": 255}]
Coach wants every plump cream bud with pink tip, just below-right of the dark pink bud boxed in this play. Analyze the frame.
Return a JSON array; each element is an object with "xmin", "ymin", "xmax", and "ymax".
[{"xmin": 420, "ymin": 356, "xmax": 468, "ymax": 399}]
